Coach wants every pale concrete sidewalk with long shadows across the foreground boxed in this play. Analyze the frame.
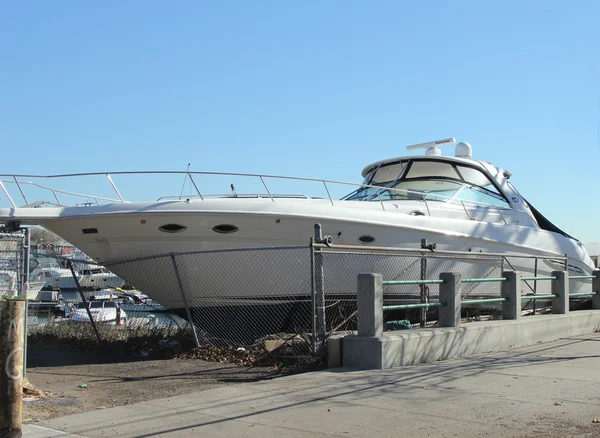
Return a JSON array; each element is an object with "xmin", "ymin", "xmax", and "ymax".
[{"xmin": 24, "ymin": 334, "xmax": 600, "ymax": 438}]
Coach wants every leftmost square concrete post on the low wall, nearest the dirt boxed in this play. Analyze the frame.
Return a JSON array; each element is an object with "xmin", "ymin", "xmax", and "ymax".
[{"xmin": 356, "ymin": 274, "xmax": 383, "ymax": 337}]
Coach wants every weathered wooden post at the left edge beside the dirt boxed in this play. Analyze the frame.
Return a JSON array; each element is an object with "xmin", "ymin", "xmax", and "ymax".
[{"xmin": 0, "ymin": 297, "xmax": 26, "ymax": 438}]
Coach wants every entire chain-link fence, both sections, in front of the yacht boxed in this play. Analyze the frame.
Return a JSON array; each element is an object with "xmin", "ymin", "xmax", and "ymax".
[{"xmin": 19, "ymin": 238, "xmax": 592, "ymax": 357}]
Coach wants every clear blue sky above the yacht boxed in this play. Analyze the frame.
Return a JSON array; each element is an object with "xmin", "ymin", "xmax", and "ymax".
[{"xmin": 0, "ymin": 1, "xmax": 600, "ymax": 242}]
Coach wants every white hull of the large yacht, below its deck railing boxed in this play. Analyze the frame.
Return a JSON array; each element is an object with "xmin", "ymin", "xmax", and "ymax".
[{"xmin": 21, "ymin": 200, "xmax": 593, "ymax": 309}]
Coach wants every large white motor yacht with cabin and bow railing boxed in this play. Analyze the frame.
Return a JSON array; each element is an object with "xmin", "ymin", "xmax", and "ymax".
[{"xmin": 0, "ymin": 138, "xmax": 594, "ymax": 309}]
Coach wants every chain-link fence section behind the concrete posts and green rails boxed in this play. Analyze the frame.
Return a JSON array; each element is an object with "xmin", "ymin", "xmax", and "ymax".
[{"xmin": 316, "ymin": 246, "xmax": 504, "ymax": 333}]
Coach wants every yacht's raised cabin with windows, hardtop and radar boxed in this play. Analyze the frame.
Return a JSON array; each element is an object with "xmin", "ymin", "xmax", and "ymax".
[{"xmin": 342, "ymin": 138, "xmax": 572, "ymax": 238}]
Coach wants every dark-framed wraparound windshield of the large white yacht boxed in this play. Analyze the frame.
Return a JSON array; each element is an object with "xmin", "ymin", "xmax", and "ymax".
[{"xmin": 343, "ymin": 160, "xmax": 510, "ymax": 208}]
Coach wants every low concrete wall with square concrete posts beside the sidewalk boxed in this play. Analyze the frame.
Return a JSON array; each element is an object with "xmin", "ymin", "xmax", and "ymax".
[{"xmin": 327, "ymin": 271, "xmax": 600, "ymax": 370}]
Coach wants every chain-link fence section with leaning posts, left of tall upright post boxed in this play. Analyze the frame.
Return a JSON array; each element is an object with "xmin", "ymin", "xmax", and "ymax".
[{"xmin": 28, "ymin": 246, "xmax": 314, "ymax": 356}]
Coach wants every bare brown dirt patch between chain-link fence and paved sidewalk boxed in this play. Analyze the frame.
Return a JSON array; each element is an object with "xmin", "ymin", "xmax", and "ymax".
[{"xmin": 23, "ymin": 345, "xmax": 298, "ymax": 422}]
